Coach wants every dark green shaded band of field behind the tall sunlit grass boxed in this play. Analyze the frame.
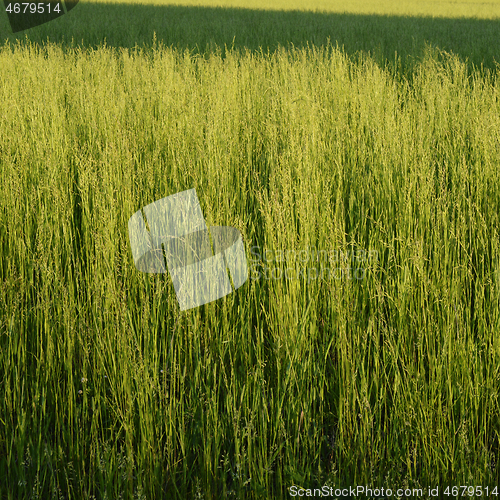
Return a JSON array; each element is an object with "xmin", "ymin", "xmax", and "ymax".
[{"xmin": 0, "ymin": 2, "xmax": 500, "ymax": 72}]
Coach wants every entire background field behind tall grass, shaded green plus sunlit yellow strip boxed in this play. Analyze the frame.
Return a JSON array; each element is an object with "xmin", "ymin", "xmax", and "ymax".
[{"xmin": 0, "ymin": 0, "xmax": 500, "ymax": 72}]
